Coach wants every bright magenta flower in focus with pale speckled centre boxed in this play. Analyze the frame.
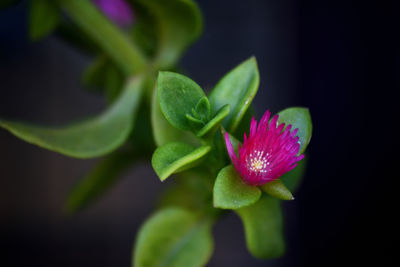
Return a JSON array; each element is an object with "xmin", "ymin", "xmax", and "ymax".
[{"xmin": 225, "ymin": 110, "xmax": 304, "ymax": 186}]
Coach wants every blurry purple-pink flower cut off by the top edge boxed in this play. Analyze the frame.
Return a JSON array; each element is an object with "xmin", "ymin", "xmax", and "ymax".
[{"xmin": 93, "ymin": 0, "xmax": 133, "ymax": 27}]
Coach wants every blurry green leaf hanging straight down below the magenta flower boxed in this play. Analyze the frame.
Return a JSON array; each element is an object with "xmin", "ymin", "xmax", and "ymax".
[{"xmin": 236, "ymin": 196, "xmax": 285, "ymax": 259}]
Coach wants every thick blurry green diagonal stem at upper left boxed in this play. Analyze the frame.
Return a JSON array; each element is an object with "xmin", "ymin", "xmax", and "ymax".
[{"xmin": 58, "ymin": 0, "xmax": 147, "ymax": 76}]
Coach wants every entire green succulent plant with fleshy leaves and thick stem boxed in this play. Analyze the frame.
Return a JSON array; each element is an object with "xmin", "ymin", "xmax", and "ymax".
[{"xmin": 0, "ymin": 0, "xmax": 312, "ymax": 267}]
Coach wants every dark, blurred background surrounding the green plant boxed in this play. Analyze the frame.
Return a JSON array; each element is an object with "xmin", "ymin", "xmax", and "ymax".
[{"xmin": 0, "ymin": 0, "xmax": 400, "ymax": 266}]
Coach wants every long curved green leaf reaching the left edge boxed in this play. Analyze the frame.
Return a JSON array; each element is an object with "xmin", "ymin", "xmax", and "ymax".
[{"xmin": 0, "ymin": 77, "xmax": 143, "ymax": 158}]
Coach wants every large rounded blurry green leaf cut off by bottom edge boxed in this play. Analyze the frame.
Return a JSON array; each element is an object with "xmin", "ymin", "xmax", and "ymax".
[{"xmin": 132, "ymin": 208, "xmax": 214, "ymax": 267}]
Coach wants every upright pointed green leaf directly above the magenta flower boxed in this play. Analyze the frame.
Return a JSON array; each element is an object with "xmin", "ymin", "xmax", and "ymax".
[{"xmin": 209, "ymin": 57, "xmax": 260, "ymax": 132}]
